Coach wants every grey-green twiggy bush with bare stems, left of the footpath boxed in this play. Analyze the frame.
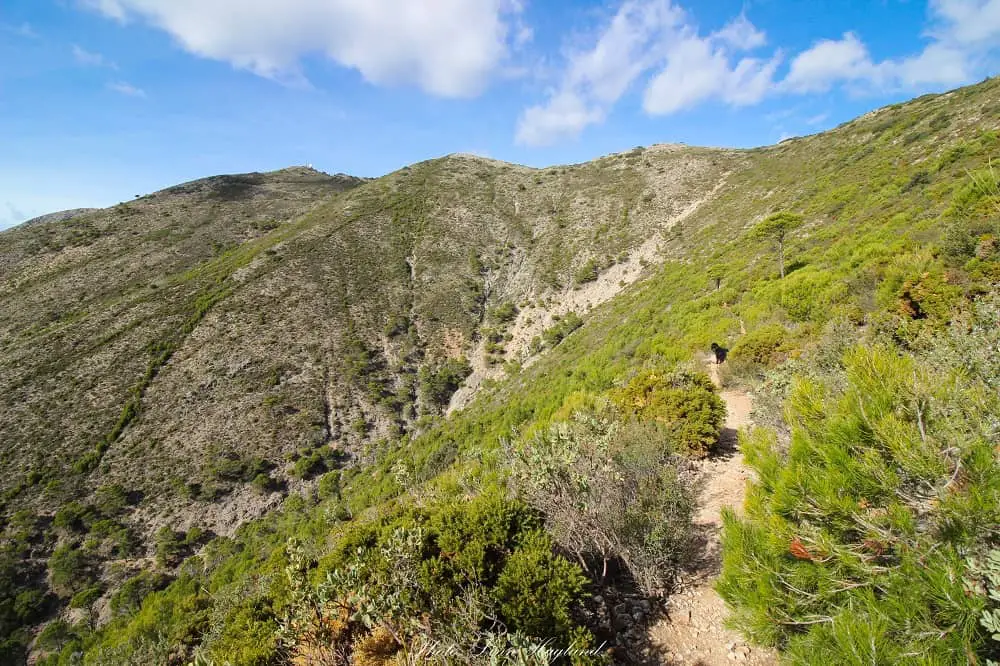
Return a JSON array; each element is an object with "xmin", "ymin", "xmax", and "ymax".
[{"xmin": 507, "ymin": 412, "xmax": 694, "ymax": 594}]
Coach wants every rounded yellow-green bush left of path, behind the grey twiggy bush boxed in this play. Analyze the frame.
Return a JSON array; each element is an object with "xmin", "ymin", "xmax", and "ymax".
[{"xmin": 613, "ymin": 370, "xmax": 726, "ymax": 458}]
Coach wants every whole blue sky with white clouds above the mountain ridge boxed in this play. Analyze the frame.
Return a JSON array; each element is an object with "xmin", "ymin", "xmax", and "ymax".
[{"xmin": 0, "ymin": 0, "xmax": 1000, "ymax": 228}]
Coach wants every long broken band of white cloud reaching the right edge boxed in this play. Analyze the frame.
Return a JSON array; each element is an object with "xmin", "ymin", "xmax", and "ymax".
[{"xmin": 515, "ymin": 0, "xmax": 1000, "ymax": 146}]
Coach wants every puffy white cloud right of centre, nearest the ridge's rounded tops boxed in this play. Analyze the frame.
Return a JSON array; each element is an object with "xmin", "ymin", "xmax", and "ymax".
[{"xmin": 516, "ymin": 0, "xmax": 778, "ymax": 145}]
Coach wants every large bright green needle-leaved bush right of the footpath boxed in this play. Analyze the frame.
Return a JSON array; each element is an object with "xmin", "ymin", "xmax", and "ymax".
[{"xmin": 718, "ymin": 348, "xmax": 1000, "ymax": 663}]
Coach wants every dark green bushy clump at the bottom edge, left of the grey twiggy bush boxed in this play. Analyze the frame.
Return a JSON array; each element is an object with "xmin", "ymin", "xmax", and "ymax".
[{"xmin": 282, "ymin": 490, "xmax": 586, "ymax": 663}]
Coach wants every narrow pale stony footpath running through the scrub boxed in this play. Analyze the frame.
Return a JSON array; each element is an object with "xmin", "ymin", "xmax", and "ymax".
[{"xmin": 649, "ymin": 364, "xmax": 778, "ymax": 666}]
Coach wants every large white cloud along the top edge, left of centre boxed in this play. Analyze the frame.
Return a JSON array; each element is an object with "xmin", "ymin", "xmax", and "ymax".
[{"xmin": 83, "ymin": 0, "xmax": 531, "ymax": 97}]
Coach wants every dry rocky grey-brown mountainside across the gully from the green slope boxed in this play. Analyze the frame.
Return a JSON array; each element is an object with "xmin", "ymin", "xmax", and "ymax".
[{"xmin": 0, "ymin": 147, "xmax": 744, "ymax": 532}]
